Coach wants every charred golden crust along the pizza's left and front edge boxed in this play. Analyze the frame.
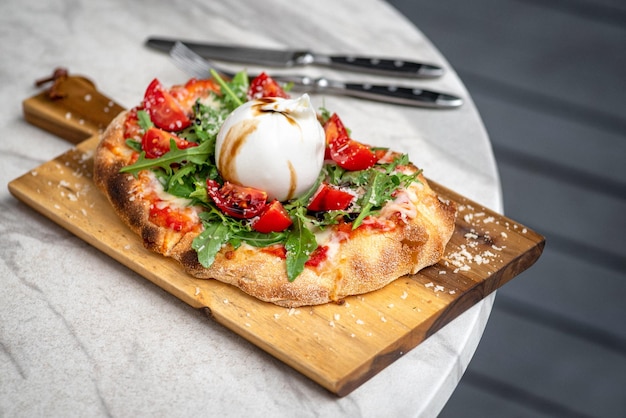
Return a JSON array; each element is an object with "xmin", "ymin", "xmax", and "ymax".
[{"xmin": 94, "ymin": 112, "xmax": 456, "ymax": 307}]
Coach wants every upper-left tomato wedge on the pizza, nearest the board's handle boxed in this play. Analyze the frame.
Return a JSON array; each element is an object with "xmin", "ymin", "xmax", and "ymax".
[{"xmin": 143, "ymin": 78, "xmax": 191, "ymax": 131}]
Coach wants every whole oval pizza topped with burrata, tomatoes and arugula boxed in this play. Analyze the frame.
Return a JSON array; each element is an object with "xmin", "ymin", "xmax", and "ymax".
[{"xmin": 94, "ymin": 72, "xmax": 456, "ymax": 307}]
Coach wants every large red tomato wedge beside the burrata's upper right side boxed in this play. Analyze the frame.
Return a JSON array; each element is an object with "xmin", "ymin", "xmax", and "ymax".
[{"xmin": 324, "ymin": 113, "xmax": 378, "ymax": 171}]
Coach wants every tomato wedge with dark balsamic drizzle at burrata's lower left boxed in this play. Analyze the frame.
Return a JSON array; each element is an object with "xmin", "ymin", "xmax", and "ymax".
[{"xmin": 206, "ymin": 179, "xmax": 267, "ymax": 219}]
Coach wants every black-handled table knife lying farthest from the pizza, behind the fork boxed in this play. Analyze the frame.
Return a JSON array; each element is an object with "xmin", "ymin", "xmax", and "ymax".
[{"xmin": 146, "ymin": 37, "xmax": 444, "ymax": 78}]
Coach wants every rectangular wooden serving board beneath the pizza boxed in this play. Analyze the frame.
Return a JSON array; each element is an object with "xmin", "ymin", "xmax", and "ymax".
[{"xmin": 9, "ymin": 73, "xmax": 544, "ymax": 396}]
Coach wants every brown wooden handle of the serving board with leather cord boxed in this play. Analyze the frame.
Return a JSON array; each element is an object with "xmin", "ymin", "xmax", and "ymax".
[{"xmin": 22, "ymin": 69, "xmax": 124, "ymax": 144}]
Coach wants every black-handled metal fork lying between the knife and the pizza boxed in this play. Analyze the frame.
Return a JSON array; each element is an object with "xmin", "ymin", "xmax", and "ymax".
[{"xmin": 169, "ymin": 42, "xmax": 463, "ymax": 109}]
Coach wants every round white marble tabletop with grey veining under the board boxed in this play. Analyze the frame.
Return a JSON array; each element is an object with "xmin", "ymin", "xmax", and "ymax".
[{"xmin": 0, "ymin": 0, "xmax": 501, "ymax": 417}]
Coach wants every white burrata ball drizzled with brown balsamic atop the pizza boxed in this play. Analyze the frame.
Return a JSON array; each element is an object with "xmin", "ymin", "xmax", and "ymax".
[{"xmin": 215, "ymin": 94, "xmax": 326, "ymax": 201}]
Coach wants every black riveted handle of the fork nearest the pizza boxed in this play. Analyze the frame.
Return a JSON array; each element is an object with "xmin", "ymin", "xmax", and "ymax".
[{"xmin": 344, "ymin": 83, "xmax": 463, "ymax": 109}]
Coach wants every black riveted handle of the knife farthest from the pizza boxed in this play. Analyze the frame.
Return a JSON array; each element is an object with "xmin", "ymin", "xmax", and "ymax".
[{"xmin": 328, "ymin": 55, "xmax": 444, "ymax": 78}]
